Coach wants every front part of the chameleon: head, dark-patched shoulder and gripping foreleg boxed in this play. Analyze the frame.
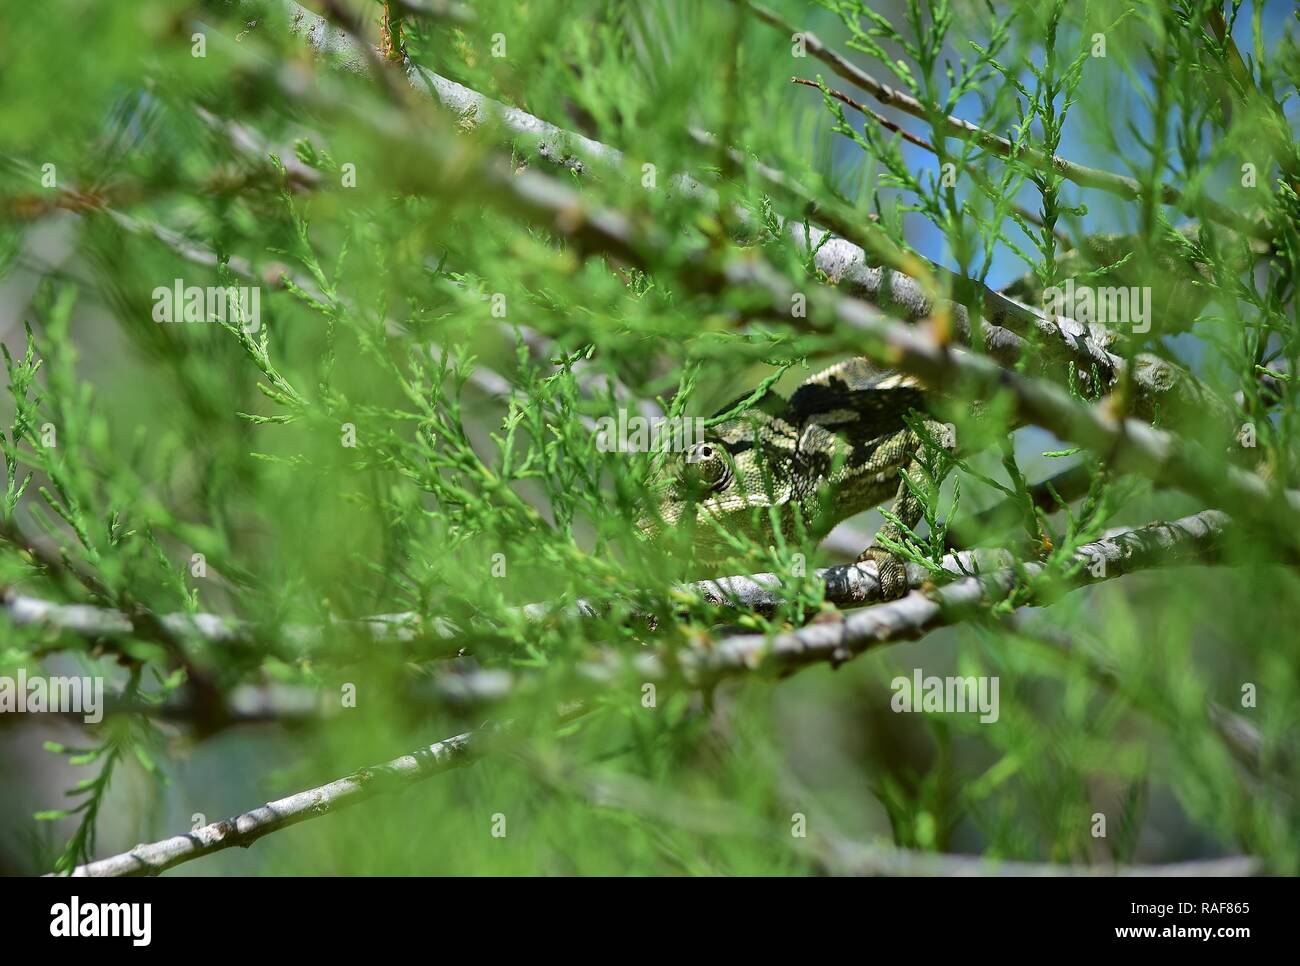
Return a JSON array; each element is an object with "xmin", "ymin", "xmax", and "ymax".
[{"xmin": 638, "ymin": 359, "xmax": 956, "ymax": 599}]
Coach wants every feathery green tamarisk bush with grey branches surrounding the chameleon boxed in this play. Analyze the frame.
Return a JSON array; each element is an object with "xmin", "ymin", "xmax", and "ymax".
[{"xmin": 0, "ymin": 0, "xmax": 1300, "ymax": 875}]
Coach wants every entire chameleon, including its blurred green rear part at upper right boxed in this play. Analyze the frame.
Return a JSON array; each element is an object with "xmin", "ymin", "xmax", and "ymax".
[{"xmin": 638, "ymin": 222, "xmax": 1257, "ymax": 585}]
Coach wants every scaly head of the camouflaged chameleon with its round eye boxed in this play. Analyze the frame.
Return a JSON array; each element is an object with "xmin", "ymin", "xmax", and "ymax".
[{"xmin": 637, "ymin": 397, "xmax": 798, "ymax": 562}]
